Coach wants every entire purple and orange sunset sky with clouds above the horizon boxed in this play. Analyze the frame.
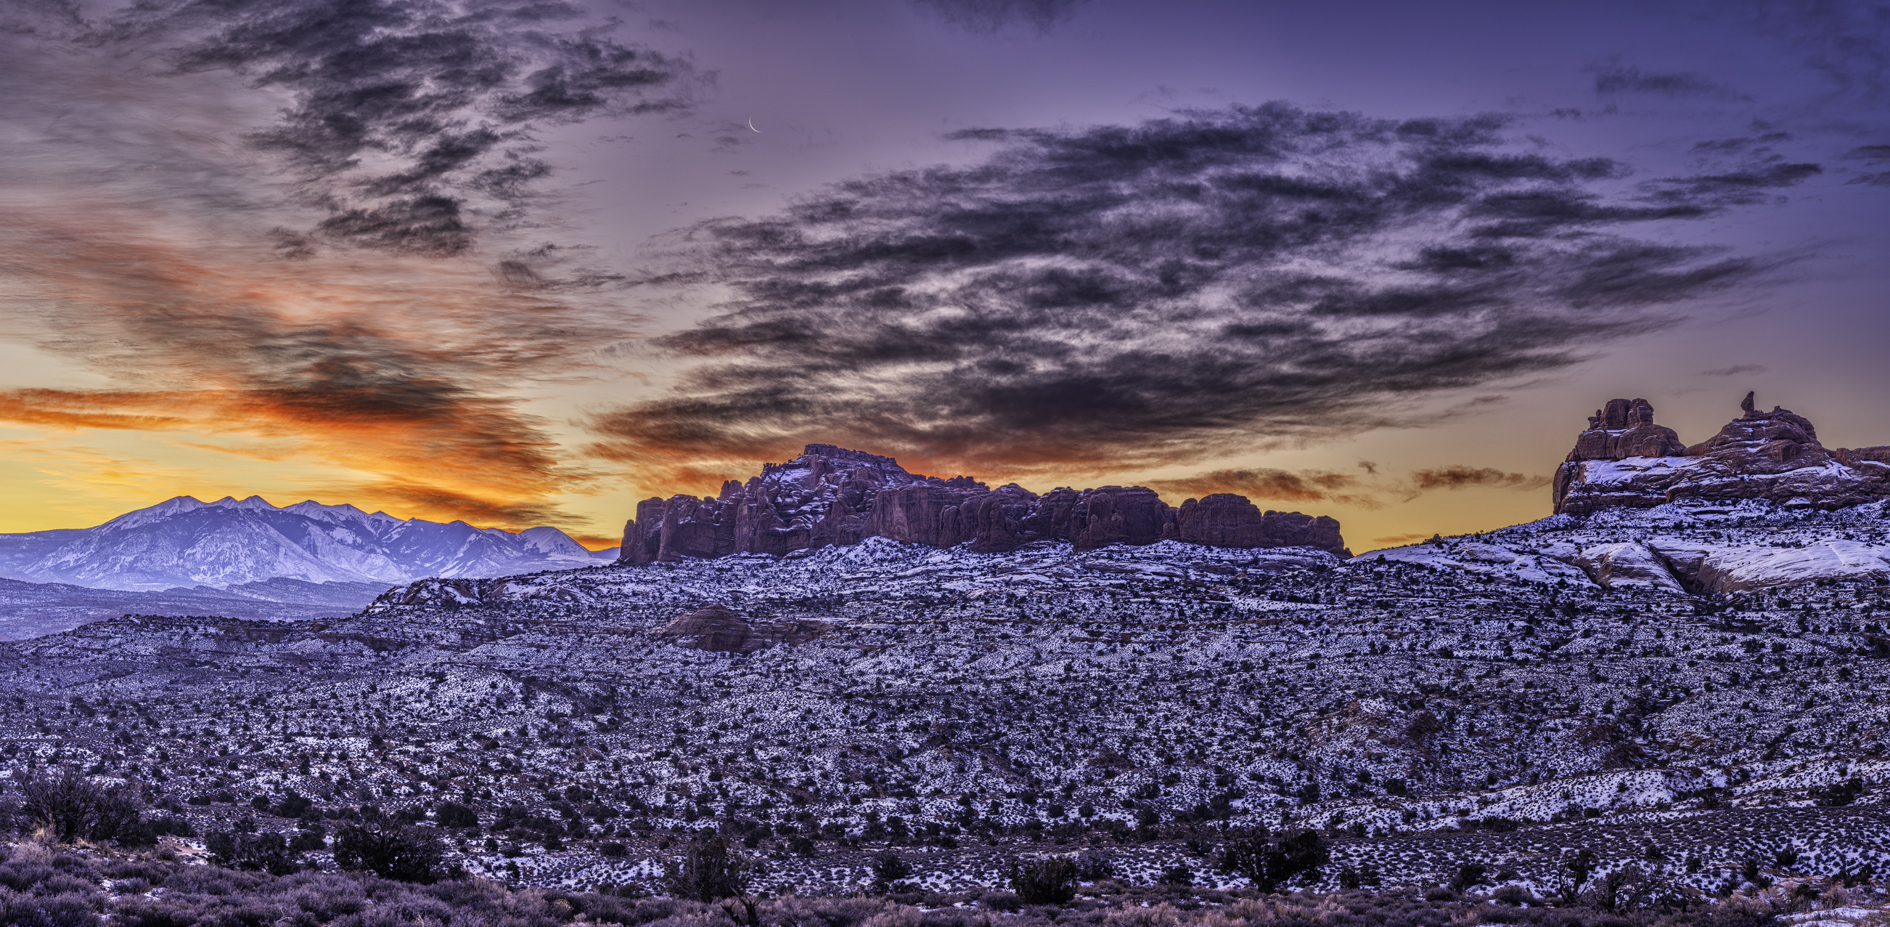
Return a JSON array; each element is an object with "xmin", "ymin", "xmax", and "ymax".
[{"xmin": 0, "ymin": 0, "xmax": 1890, "ymax": 551}]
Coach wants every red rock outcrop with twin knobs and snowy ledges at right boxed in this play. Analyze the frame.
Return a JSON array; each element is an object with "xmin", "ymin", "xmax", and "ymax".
[{"xmin": 1554, "ymin": 394, "xmax": 1890, "ymax": 515}]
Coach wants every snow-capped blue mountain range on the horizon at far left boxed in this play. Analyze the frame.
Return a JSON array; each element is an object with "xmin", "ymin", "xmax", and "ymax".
[{"xmin": 0, "ymin": 496, "xmax": 614, "ymax": 590}]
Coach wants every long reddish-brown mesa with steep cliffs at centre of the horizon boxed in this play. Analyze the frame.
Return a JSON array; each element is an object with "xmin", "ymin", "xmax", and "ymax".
[{"xmin": 622, "ymin": 445, "xmax": 1349, "ymax": 564}]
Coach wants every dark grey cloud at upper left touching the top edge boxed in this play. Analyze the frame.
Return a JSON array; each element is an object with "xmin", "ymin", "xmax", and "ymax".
[{"xmin": 105, "ymin": 0, "xmax": 703, "ymax": 255}]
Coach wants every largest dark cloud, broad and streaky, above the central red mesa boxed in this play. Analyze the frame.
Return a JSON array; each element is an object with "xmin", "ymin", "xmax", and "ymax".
[{"xmin": 595, "ymin": 104, "xmax": 1803, "ymax": 475}]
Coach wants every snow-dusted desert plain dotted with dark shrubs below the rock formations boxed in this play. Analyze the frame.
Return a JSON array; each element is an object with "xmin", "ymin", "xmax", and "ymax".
[{"xmin": 0, "ymin": 505, "xmax": 1890, "ymax": 891}]
